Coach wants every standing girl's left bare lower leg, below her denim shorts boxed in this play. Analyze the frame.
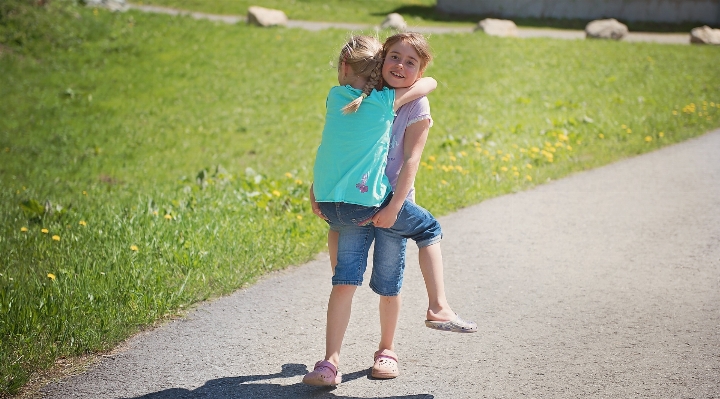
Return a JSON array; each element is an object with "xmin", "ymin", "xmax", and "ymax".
[{"xmin": 325, "ymin": 285, "xmax": 357, "ymax": 367}]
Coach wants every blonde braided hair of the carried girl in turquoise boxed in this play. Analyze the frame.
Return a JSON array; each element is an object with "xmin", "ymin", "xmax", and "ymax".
[{"xmin": 338, "ymin": 36, "xmax": 383, "ymax": 114}]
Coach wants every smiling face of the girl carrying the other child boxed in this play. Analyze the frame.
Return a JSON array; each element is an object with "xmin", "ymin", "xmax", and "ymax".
[{"xmin": 382, "ymin": 40, "xmax": 423, "ymax": 89}]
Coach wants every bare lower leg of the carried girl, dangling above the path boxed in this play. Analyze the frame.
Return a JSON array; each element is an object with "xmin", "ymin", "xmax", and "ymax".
[{"xmin": 419, "ymin": 243, "xmax": 455, "ymax": 321}]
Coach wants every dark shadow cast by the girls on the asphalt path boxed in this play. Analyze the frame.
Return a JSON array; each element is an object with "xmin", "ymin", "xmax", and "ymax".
[{"xmin": 124, "ymin": 363, "xmax": 434, "ymax": 399}]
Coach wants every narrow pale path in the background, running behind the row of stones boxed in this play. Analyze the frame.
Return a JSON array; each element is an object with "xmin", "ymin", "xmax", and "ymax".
[{"xmin": 129, "ymin": 4, "xmax": 690, "ymax": 44}]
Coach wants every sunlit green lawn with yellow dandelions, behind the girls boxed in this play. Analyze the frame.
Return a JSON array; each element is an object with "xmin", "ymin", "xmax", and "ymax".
[{"xmin": 0, "ymin": 3, "xmax": 720, "ymax": 395}]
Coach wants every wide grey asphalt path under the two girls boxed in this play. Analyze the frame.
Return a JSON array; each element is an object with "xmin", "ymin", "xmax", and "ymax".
[{"xmin": 42, "ymin": 130, "xmax": 720, "ymax": 399}]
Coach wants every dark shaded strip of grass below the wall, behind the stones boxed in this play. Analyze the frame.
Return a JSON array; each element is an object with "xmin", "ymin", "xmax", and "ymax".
[{"xmin": 372, "ymin": 5, "xmax": 707, "ymax": 33}]
